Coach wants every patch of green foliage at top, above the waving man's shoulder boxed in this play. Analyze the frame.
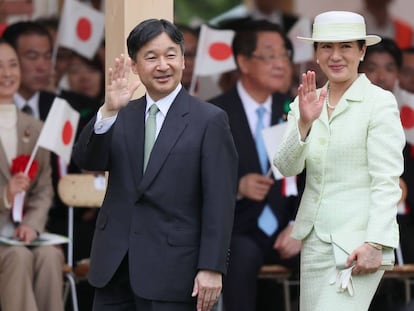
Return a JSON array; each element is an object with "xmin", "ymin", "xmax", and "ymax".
[{"xmin": 174, "ymin": 0, "xmax": 242, "ymax": 24}]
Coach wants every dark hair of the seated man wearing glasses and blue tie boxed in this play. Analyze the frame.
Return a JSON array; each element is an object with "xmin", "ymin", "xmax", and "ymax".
[{"xmin": 232, "ymin": 20, "xmax": 293, "ymax": 64}]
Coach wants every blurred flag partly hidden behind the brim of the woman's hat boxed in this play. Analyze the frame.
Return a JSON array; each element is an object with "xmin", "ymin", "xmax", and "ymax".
[{"xmin": 287, "ymin": 18, "xmax": 314, "ymax": 64}]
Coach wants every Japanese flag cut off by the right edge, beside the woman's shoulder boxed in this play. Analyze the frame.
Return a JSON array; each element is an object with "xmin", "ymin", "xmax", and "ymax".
[{"xmin": 394, "ymin": 87, "xmax": 414, "ymax": 145}]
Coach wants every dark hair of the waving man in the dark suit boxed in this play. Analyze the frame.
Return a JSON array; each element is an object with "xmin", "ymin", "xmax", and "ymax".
[{"xmin": 127, "ymin": 18, "xmax": 184, "ymax": 61}]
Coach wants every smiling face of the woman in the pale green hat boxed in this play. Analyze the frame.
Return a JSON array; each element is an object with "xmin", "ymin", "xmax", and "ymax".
[{"xmin": 316, "ymin": 41, "xmax": 366, "ymax": 84}]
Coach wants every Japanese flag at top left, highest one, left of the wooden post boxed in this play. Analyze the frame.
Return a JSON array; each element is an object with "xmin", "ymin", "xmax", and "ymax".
[{"xmin": 57, "ymin": 0, "xmax": 105, "ymax": 59}]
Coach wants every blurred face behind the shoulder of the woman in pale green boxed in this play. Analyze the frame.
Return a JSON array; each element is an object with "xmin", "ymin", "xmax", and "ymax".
[{"xmin": 360, "ymin": 52, "xmax": 398, "ymax": 92}]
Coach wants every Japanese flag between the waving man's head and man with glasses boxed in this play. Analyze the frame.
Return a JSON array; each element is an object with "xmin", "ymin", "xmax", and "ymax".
[{"xmin": 194, "ymin": 25, "xmax": 236, "ymax": 76}]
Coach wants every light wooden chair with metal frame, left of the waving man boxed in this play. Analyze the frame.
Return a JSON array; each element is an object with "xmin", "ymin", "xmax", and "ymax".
[{"xmin": 58, "ymin": 174, "xmax": 107, "ymax": 311}]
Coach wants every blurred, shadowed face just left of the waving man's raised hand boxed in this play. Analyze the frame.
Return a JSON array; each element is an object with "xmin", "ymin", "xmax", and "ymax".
[{"xmin": 68, "ymin": 55, "xmax": 104, "ymax": 97}]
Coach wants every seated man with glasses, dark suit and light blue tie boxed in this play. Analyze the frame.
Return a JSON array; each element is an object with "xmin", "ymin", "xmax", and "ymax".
[{"xmin": 210, "ymin": 21, "xmax": 300, "ymax": 311}]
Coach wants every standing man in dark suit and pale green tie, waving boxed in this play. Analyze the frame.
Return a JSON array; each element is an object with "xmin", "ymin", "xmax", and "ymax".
[{"xmin": 73, "ymin": 19, "xmax": 238, "ymax": 311}]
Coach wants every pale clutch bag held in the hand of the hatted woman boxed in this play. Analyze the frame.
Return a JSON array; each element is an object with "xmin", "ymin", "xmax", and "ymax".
[{"xmin": 331, "ymin": 231, "xmax": 395, "ymax": 270}]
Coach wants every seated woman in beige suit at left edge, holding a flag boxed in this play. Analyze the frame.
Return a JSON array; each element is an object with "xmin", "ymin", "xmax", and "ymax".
[{"xmin": 0, "ymin": 39, "xmax": 64, "ymax": 311}]
